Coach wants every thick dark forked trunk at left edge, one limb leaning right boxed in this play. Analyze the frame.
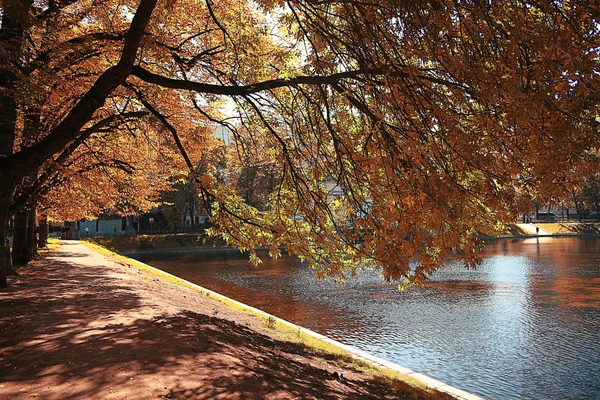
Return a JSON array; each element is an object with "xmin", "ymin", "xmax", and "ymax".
[{"xmin": 0, "ymin": 0, "xmax": 157, "ymax": 287}]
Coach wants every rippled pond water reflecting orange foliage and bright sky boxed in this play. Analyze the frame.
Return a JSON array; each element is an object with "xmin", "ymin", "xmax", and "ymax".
[{"xmin": 140, "ymin": 238, "xmax": 600, "ymax": 399}]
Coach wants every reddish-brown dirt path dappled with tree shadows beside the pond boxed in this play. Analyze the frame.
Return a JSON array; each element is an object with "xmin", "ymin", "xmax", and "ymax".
[{"xmin": 0, "ymin": 242, "xmax": 440, "ymax": 399}]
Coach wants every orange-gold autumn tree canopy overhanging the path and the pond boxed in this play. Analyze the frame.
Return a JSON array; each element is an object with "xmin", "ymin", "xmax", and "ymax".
[{"xmin": 0, "ymin": 0, "xmax": 600, "ymax": 288}]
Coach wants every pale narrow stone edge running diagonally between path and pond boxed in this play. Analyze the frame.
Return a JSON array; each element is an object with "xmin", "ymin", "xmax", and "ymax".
[{"xmin": 82, "ymin": 241, "xmax": 482, "ymax": 400}]
